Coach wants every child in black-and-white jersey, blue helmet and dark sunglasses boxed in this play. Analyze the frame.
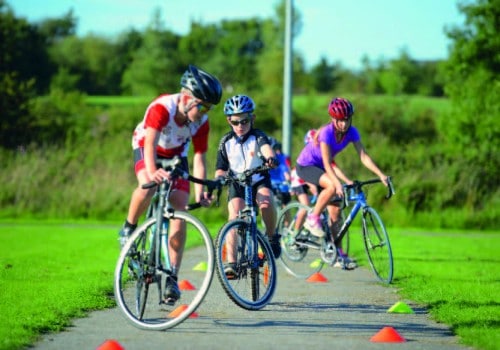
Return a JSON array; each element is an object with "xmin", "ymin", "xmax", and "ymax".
[{"xmin": 215, "ymin": 95, "xmax": 281, "ymax": 278}]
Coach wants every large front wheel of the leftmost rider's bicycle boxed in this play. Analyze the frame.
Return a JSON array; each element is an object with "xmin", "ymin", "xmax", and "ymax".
[{"xmin": 114, "ymin": 211, "xmax": 215, "ymax": 330}]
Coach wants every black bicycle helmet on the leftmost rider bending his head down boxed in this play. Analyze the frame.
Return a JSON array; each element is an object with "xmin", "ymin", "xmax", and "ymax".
[{"xmin": 181, "ymin": 64, "xmax": 222, "ymax": 105}]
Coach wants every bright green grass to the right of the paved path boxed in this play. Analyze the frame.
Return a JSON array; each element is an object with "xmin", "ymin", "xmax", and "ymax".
[{"xmin": 350, "ymin": 229, "xmax": 500, "ymax": 349}]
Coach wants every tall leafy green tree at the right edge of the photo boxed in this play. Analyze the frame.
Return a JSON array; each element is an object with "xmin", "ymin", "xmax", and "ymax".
[{"xmin": 442, "ymin": 0, "xmax": 500, "ymax": 207}]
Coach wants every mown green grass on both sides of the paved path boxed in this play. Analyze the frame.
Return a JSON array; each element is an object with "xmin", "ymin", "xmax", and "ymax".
[{"xmin": 0, "ymin": 222, "xmax": 500, "ymax": 349}]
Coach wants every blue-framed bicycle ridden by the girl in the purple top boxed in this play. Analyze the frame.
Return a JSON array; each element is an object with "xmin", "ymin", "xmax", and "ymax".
[{"xmin": 277, "ymin": 177, "xmax": 395, "ymax": 284}]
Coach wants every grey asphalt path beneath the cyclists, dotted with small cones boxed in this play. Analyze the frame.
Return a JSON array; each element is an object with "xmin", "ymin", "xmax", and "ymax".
[{"xmin": 34, "ymin": 254, "xmax": 470, "ymax": 350}]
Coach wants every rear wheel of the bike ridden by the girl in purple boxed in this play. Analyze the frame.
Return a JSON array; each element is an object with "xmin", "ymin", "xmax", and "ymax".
[{"xmin": 276, "ymin": 202, "xmax": 324, "ymax": 279}]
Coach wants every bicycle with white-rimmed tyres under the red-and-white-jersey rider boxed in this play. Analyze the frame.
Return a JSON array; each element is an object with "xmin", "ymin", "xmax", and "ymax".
[{"xmin": 114, "ymin": 157, "xmax": 220, "ymax": 330}]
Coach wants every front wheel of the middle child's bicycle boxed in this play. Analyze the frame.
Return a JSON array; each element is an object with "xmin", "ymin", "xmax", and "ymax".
[{"xmin": 215, "ymin": 219, "xmax": 278, "ymax": 310}]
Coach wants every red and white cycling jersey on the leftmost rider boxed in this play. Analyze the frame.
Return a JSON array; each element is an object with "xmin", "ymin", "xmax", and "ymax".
[{"xmin": 132, "ymin": 94, "xmax": 210, "ymax": 158}]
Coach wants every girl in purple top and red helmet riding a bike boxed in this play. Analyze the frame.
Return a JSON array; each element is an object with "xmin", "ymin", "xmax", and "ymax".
[{"xmin": 296, "ymin": 97, "xmax": 387, "ymax": 241}]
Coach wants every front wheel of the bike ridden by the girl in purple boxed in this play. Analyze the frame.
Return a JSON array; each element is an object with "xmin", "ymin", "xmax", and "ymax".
[{"xmin": 363, "ymin": 207, "xmax": 394, "ymax": 284}]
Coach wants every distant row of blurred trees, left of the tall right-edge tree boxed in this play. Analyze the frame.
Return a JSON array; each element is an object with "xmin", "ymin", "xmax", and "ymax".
[{"xmin": 0, "ymin": 0, "xmax": 450, "ymax": 148}]
